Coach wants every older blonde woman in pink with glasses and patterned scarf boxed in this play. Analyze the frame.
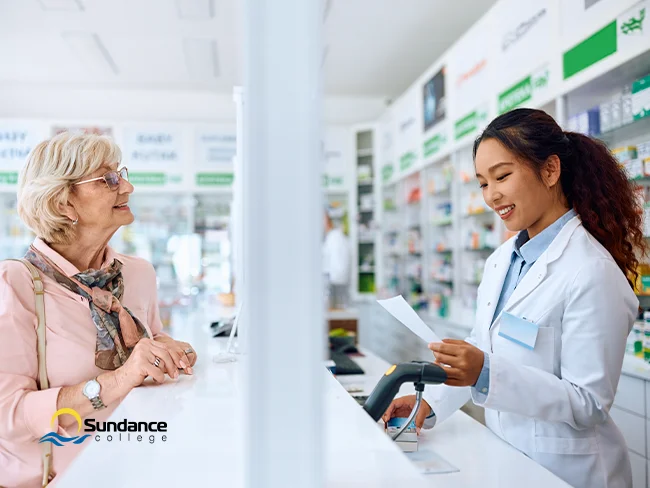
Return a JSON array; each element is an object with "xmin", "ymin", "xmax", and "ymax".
[{"xmin": 0, "ymin": 133, "xmax": 196, "ymax": 488}]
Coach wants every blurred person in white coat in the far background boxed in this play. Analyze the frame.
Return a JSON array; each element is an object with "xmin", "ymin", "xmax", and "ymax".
[{"xmin": 323, "ymin": 210, "xmax": 351, "ymax": 309}]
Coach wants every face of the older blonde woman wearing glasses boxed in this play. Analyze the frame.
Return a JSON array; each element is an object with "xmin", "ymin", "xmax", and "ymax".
[{"xmin": 66, "ymin": 163, "xmax": 134, "ymax": 238}]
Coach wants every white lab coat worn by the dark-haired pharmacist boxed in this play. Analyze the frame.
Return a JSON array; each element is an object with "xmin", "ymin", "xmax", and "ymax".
[{"xmin": 424, "ymin": 217, "xmax": 641, "ymax": 488}]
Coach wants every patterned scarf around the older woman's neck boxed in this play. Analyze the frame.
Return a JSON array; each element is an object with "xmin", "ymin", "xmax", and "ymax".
[{"xmin": 25, "ymin": 246, "xmax": 149, "ymax": 370}]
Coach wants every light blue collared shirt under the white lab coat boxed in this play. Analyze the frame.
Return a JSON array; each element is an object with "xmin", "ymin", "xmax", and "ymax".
[{"xmin": 473, "ymin": 209, "xmax": 577, "ymax": 395}]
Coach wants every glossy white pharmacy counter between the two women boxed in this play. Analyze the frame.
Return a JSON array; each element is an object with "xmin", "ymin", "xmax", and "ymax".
[{"xmin": 56, "ymin": 314, "xmax": 567, "ymax": 488}]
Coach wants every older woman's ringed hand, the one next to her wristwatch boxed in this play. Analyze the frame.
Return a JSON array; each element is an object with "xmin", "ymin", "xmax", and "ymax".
[{"xmin": 115, "ymin": 339, "xmax": 178, "ymax": 390}]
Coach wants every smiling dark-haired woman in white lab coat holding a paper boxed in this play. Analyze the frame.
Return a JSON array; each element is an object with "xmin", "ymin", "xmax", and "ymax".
[{"xmin": 384, "ymin": 109, "xmax": 645, "ymax": 488}]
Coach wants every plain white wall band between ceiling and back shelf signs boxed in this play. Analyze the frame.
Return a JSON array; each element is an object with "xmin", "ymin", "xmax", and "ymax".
[{"xmin": 0, "ymin": 85, "xmax": 385, "ymax": 125}]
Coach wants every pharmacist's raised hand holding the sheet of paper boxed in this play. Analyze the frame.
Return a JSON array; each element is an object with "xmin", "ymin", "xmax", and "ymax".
[{"xmin": 429, "ymin": 339, "xmax": 485, "ymax": 386}]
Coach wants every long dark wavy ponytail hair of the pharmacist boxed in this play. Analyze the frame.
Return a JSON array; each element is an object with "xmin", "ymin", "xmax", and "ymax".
[{"xmin": 473, "ymin": 108, "xmax": 647, "ymax": 288}]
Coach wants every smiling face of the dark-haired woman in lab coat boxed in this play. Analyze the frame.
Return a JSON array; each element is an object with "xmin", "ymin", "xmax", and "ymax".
[{"xmin": 475, "ymin": 139, "xmax": 560, "ymax": 238}]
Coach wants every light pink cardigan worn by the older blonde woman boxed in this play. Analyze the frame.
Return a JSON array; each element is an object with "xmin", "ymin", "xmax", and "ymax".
[{"xmin": 0, "ymin": 239, "xmax": 162, "ymax": 488}]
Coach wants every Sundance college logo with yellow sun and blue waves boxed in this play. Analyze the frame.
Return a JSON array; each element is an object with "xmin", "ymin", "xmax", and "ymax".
[{"xmin": 38, "ymin": 408, "xmax": 167, "ymax": 447}]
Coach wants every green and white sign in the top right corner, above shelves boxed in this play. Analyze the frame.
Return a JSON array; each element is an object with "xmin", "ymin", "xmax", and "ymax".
[{"xmin": 563, "ymin": 0, "xmax": 650, "ymax": 80}]
